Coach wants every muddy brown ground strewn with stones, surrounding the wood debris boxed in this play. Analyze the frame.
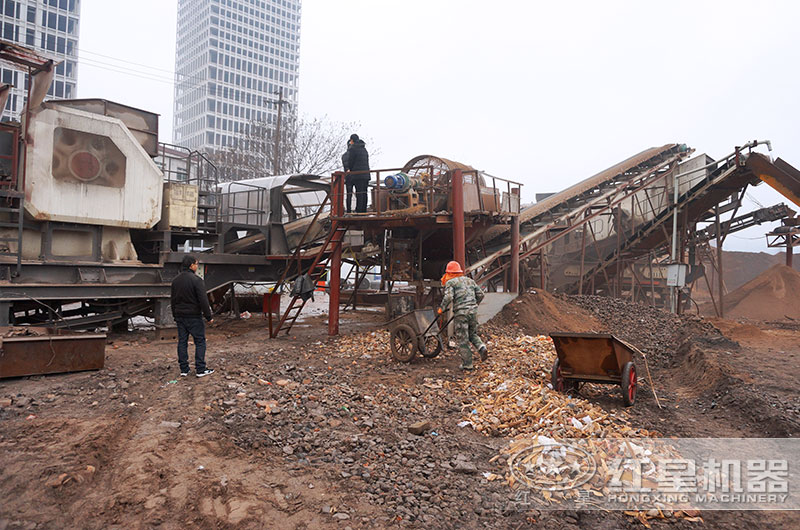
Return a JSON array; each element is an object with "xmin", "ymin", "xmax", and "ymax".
[{"xmin": 0, "ymin": 295, "xmax": 800, "ymax": 529}]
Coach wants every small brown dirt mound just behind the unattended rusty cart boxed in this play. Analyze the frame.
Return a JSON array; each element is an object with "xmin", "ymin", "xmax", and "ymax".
[{"xmin": 491, "ymin": 290, "xmax": 602, "ymax": 335}]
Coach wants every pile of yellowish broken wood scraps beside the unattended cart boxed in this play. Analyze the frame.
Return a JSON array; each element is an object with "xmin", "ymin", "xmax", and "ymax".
[{"xmin": 451, "ymin": 330, "xmax": 699, "ymax": 525}]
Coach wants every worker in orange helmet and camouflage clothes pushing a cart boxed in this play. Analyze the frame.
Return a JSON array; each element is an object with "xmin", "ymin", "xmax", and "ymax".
[{"xmin": 439, "ymin": 261, "xmax": 488, "ymax": 370}]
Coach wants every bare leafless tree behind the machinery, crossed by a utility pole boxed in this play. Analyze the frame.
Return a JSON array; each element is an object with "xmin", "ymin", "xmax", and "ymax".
[{"xmin": 212, "ymin": 115, "xmax": 366, "ymax": 182}]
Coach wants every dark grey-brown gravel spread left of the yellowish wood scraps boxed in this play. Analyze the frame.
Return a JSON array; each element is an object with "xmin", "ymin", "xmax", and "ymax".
[{"xmin": 211, "ymin": 331, "xmax": 525, "ymax": 527}]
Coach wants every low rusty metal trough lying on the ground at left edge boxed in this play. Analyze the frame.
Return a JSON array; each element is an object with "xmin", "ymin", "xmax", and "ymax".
[{"xmin": 0, "ymin": 327, "xmax": 106, "ymax": 379}]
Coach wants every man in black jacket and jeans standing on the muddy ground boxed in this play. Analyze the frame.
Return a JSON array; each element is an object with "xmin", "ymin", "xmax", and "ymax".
[{"xmin": 171, "ymin": 255, "xmax": 214, "ymax": 377}]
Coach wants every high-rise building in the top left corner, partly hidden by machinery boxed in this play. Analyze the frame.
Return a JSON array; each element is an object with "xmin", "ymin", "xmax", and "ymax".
[{"xmin": 0, "ymin": 0, "xmax": 81, "ymax": 120}]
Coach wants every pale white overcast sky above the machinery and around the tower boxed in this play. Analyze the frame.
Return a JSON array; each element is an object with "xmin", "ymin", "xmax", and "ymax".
[{"xmin": 78, "ymin": 0, "xmax": 800, "ymax": 251}]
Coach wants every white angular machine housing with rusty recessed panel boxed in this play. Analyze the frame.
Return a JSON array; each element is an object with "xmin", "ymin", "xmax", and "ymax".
[{"xmin": 25, "ymin": 103, "xmax": 163, "ymax": 229}]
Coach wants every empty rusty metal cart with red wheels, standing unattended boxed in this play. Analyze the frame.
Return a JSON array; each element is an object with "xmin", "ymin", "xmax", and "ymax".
[{"xmin": 550, "ymin": 333, "xmax": 642, "ymax": 407}]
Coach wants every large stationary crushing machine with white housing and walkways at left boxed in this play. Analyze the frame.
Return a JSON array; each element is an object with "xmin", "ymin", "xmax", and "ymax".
[{"xmin": 0, "ymin": 42, "xmax": 330, "ymax": 328}]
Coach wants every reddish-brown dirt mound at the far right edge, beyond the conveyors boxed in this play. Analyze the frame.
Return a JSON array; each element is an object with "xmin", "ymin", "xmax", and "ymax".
[{"xmin": 725, "ymin": 265, "xmax": 800, "ymax": 320}]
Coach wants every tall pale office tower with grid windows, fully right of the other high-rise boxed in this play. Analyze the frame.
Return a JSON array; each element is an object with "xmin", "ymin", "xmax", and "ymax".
[{"xmin": 173, "ymin": 0, "xmax": 300, "ymax": 161}]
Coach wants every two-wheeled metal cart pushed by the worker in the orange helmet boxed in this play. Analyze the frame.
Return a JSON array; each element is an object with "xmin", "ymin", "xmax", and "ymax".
[{"xmin": 386, "ymin": 309, "xmax": 447, "ymax": 363}]
